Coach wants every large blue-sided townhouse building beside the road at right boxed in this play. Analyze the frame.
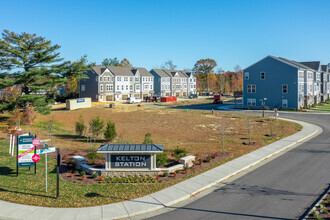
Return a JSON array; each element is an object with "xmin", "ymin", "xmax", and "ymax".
[{"xmin": 243, "ymin": 56, "xmax": 319, "ymax": 109}]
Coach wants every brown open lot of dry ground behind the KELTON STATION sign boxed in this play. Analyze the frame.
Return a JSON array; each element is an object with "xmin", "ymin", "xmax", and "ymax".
[{"xmin": 3, "ymin": 105, "xmax": 301, "ymax": 157}]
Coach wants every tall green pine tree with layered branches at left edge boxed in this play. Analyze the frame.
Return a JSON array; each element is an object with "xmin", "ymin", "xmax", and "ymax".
[{"xmin": 0, "ymin": 30, "xmax": 68, "ymax": 114}]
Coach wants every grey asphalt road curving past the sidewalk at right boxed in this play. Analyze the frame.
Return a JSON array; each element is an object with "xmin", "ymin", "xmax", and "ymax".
[{"xmin": 151, "ymin": 113, "xmax": 330, "ymax": 220}]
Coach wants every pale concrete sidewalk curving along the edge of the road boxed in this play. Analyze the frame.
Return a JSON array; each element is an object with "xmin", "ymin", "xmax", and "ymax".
[{"xmin": 0, "ymin": 119, "xmax": 322, "ymax": 220}]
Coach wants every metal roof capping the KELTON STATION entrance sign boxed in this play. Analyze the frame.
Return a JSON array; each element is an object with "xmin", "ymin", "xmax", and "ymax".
[{"xmin": 97, "ymin": 144, "xmax": 163, "ymax": 153}]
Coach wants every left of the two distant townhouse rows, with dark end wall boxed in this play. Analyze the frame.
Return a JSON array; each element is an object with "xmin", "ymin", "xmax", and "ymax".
[{"xmin": 79, "ymin": 65, "xmax": 153, "ymax": 102}]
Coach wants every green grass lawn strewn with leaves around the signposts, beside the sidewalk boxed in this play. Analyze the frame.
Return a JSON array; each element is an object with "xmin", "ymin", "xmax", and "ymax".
[{"xmin": 0, "ymin": 141, "xmax": 168, "ymax": 207}]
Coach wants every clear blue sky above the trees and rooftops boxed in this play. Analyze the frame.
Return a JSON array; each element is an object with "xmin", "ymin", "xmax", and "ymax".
[{"xmin": 0, "ymin": 0, "xmax": 330, "ymax": 70}]
